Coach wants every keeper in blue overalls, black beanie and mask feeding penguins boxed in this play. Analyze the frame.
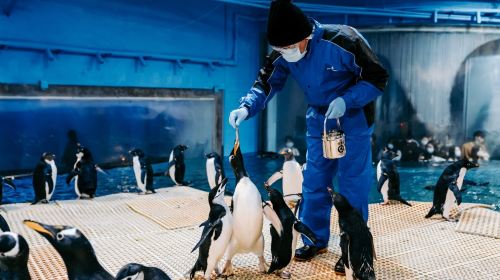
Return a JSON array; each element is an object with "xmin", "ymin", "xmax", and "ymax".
[{"xmin": 229, "ymin": 0, "xmax": 388, "ymax": 270}]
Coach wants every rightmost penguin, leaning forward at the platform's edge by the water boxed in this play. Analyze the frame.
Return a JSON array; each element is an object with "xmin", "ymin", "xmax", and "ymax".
[{"xmin": 425, "ymin": 159, "xmax": 479, "ymax": 220}]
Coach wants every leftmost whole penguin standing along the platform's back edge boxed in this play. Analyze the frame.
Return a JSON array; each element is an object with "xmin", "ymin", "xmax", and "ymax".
[{"xmin": 32, "ymin": 153, "xmax": 57, "ymax": 204}]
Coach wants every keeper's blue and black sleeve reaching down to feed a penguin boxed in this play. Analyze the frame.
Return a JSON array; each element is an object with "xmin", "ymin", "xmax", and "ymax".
[{"xmin": 240, "ymin": 51, "xmax": 288, "ymax": 118}]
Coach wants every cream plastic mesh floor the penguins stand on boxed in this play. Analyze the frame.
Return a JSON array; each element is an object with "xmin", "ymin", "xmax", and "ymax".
[{"xmin": 2, "ymin": 187, "xmax": 500, "ymax": 280}]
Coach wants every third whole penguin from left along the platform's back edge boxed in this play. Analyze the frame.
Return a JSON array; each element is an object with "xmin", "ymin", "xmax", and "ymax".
[{"xmin": 129, "ymin": 148, "xmax": 155, "ymax": 193}]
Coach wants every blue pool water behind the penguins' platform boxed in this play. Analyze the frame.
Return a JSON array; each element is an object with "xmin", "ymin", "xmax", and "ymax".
[{"xmin": 3, "ymin": 155, "xmax": 500, "ymax": 211}]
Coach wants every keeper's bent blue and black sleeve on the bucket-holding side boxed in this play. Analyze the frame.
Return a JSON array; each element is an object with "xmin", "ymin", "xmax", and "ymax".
[{"xmin": 333, "ymin": 27, "xmax": 389, "ymax": 109}]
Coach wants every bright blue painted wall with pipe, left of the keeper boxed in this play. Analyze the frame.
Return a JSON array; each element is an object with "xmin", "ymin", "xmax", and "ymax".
[{"xmin": 0, "ymin": 0, "xmax": 267, "ymax": 152}]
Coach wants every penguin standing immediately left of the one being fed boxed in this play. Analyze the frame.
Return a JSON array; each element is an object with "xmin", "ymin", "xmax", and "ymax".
[{"xmin": 190, "ymin": 178, "xmax": 233, "ymax": 280}]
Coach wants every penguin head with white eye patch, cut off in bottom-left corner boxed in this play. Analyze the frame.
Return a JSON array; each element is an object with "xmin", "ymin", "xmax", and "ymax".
[{"xmin": 0, "ymin": 231, "xmax": 31, "ymax": 280}]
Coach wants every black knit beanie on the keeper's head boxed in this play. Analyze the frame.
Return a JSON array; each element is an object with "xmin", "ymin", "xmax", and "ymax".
[{"xmin": 267, "ymin": 0, "xmax": 312, "ymax": 47}]
